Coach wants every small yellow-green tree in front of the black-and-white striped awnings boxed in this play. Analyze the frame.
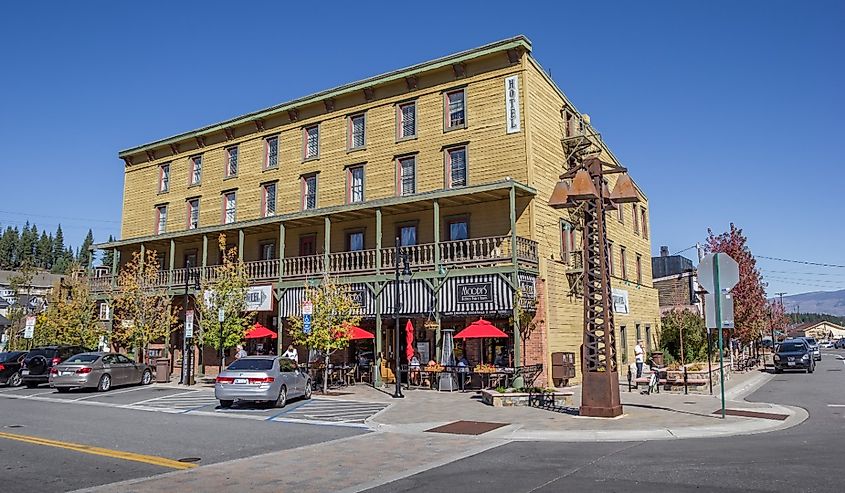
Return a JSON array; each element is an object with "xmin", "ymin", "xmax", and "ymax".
[{"xmin": 288, "ymin": 275, "xmax": 361, "ymax": 393}]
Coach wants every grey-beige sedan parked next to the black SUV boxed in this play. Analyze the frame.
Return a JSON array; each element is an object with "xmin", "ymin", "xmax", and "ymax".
[{"xmin": 50, "ymin": 353, "xmax": 153, "ymax": 392}]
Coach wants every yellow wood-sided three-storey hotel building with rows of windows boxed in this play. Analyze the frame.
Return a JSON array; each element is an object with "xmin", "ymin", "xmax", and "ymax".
[{"xmin": 92, "ymin": 36, "xmax": 660, "ymax": 383}]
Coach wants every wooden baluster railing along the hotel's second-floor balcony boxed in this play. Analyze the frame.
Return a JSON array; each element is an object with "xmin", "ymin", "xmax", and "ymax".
[{"xmin": 90, "ymin": 236, "xmax": 538, "ymax": 292}]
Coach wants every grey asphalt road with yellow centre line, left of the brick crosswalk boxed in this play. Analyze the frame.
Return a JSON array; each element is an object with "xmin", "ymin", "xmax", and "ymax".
[{"xmin": 0, "ymin": 387, "xmax": 364, "ymax": 493}]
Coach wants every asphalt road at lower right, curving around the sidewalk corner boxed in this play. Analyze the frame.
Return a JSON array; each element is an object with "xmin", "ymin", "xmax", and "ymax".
[{"xmin": 370, "ymin": 351, "xmax": 845, "ymax": 493}]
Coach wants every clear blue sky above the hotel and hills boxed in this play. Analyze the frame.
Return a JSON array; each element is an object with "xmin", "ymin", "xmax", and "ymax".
[{"xmin": 0, "ymin": 1, "xmax": 845, "ymax": 293}]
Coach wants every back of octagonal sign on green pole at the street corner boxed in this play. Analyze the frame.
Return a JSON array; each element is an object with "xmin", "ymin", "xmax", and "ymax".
[{"xmin": 698, "ymin": 253, "xmax": 739, "ymax": 419}]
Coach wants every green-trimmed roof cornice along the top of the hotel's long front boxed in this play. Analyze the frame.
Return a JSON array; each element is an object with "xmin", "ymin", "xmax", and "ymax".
[{"xmin": 118, "ymin": 34, "xmax": 531, "ymax": 158}]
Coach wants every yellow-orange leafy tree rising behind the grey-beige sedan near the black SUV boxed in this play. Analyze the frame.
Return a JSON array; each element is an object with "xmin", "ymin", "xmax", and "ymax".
[{"xmin": 109, "ymin": 250, "xmax": 178, "ymax": 360}]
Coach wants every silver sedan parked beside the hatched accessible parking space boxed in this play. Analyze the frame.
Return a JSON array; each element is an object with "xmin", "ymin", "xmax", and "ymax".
[{"xmin": 214, "ymin": 356, "xmax": 311, "ymax": 408}]
